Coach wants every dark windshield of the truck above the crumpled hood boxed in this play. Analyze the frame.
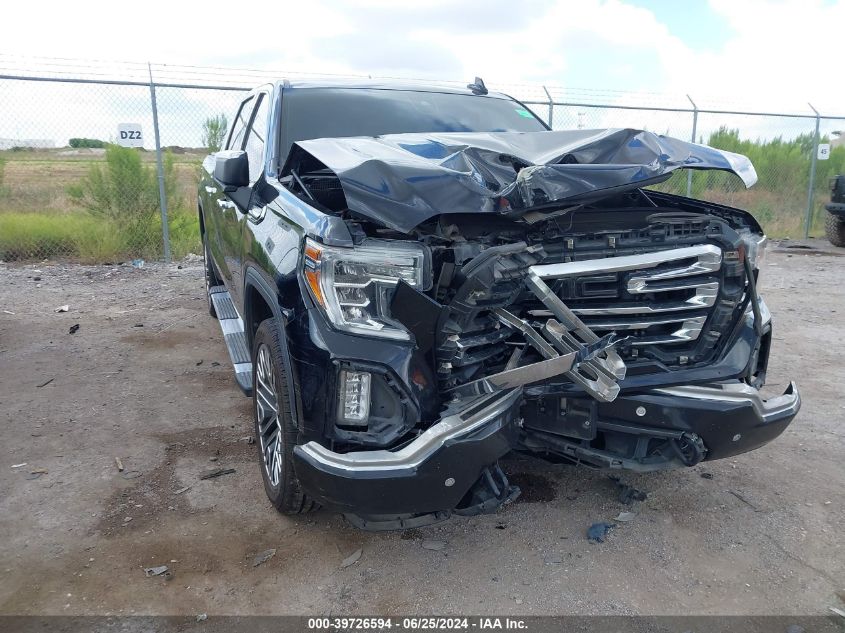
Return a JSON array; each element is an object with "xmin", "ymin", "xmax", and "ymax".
[{"xmin": 281, "ymin": 88, "xmax": 548, "ymax": 162}]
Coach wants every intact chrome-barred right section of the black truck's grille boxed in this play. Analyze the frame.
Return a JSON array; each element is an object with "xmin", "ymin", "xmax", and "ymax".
[{"xmin": 529, "ymin": 244, "xmax": 722, "ymax": 346}]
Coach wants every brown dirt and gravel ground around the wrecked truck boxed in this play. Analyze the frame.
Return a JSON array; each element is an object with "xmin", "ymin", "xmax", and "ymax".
[{"xmin": 0, "ymin": 242, "xmax": 845, "ymax": 615}]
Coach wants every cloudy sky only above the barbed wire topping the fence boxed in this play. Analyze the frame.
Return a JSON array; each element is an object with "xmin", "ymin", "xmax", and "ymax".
[{"xmin": 0, "ymin": 0, "xmax": 845, "ymax": 113}]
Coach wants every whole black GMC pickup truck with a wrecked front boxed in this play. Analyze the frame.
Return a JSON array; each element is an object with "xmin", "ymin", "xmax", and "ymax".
[{"xmin": 198, "ymin": 80, "xmax": 800, "ymax": 529}]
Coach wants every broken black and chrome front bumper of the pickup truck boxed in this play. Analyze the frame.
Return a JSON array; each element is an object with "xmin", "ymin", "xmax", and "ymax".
[{"xmin": 294, "ymin": 381, "xmax": 801, "ymax": 516}]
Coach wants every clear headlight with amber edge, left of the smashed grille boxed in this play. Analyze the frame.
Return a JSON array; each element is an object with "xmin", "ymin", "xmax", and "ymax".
[{"xmin": 303, "ymin": 239, "xmax": 427, "ymax": 340}]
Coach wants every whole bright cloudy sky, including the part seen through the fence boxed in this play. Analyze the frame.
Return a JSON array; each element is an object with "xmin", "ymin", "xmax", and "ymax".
[{"xmin": 0, "ymin": 0, "xmax": 845, "ymax": 145}]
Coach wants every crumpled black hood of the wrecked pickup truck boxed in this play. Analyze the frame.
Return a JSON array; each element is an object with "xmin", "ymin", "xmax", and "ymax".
[{"xmin": 285, "ymin": 129, "xmax": 757, "ymax": 232}]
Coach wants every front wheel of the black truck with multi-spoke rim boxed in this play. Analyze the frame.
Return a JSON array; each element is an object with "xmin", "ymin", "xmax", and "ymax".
[{"xmin": 252, "ymin": 319, "xmax": 317, "ymax": 514}]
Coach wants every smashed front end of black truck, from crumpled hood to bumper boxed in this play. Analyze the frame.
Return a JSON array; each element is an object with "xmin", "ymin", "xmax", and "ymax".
[{"xmin": 287, "ymin": 130, "xmax": 800, "ymax": 529}]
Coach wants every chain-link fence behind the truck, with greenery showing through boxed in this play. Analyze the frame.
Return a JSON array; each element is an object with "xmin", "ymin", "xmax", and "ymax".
[{"xmin": 0, "ymin": 68, "xmax": 845, "ymax": 262}]
